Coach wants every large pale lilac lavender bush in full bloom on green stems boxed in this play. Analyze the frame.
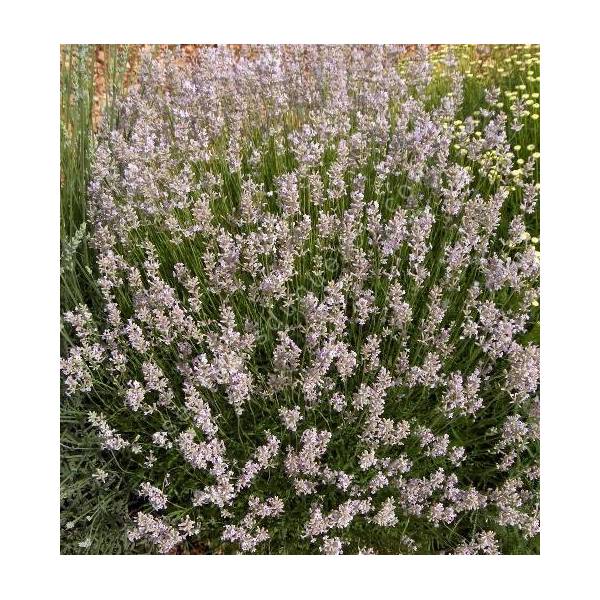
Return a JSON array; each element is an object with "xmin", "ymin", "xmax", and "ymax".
[{"xmin": 61, "ymin": 46, "xmax": 539, "ymax": 554}]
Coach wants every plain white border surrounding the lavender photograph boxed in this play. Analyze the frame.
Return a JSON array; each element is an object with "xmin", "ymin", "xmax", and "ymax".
[{"xmin": 0, "ymin": 0, "xmax": 600, "ymax": 599}]
